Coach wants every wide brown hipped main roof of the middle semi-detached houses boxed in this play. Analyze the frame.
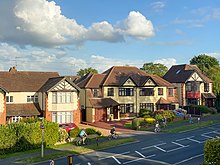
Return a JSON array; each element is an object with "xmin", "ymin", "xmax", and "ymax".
[{"xmin": 77, "ymin": 66, "xmax": 174, "ymax": 88}]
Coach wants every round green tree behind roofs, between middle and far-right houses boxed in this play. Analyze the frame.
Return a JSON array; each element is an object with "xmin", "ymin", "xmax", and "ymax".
[{"xmin": 140, "ymin": 62, "xmax": 168, "ymax": 77}]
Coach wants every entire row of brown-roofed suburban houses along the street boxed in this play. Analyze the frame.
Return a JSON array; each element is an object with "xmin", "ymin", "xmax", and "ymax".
[{"xmin": 0, "ymin": 64, "xmax": 215, "ymax": 124}]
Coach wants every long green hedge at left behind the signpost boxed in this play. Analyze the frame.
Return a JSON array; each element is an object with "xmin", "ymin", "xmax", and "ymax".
[{"xmin": 0, "ymin": 121, "xmax": 59, "ymax": 154}]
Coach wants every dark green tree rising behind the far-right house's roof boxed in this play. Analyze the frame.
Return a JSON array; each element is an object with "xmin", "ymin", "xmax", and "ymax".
[{"xmin": 190, "ymin": 54, "xmax": 219, "ymax": 74}]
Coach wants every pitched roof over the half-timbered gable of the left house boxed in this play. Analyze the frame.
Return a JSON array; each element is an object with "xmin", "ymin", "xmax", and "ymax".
[{"xmin": 39, "ymin": 76, "xmax": 80, "ymax": 92}]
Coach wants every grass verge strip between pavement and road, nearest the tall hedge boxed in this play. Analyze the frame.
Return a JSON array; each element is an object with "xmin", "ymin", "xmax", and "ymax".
[{"xmin": 16, "ymin": 138, "xmax": 135, "ymax": 163}]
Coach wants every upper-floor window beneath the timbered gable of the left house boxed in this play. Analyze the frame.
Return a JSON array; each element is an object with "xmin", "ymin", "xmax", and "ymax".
[{"xmin": 52, "ymin": 92, "xmax": 73, "ymax": 104}]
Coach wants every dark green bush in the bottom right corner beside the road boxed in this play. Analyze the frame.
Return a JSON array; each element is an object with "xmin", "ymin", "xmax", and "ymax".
[{"xmin": 204, "ymin": 138, "xmax": 220, "ymax": 165}]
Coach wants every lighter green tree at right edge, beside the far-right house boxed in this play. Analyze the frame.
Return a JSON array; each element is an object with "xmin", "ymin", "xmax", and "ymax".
[{"xmin": 207, "ymin": 65, "xmax": 220, "ymax": 95}]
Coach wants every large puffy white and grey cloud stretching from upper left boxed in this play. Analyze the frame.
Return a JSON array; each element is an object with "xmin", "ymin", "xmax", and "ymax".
[{"xmin": 0, "ymin": 0, "xmax": 154, "ymax": 47}]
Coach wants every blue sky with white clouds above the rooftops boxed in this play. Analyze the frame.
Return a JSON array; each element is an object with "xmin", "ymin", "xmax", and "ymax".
[{"xmin": 0, "ymin": 0, "xmax": 220, "ymax": 76}]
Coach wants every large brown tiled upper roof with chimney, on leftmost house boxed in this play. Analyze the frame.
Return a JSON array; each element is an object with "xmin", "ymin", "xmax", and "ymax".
[{"xmin": 0, "ymin": 67, "xmax": 59, "ymax": 92}]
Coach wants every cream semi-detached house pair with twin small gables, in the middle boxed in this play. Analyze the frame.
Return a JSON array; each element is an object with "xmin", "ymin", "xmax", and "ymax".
[{"xmin": 76, "ymin": 66, "xmax": 178, "ymax": 122}]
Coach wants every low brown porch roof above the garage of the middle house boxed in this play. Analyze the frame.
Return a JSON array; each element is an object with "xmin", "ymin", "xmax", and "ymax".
[{"xmin": 89, "ymin": 98, "xmax": 119, "ymax": 108}]
